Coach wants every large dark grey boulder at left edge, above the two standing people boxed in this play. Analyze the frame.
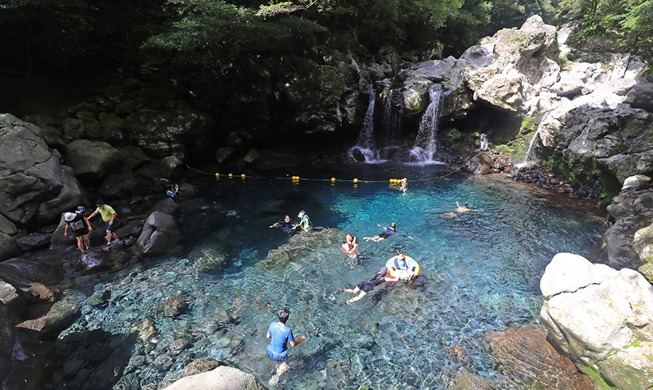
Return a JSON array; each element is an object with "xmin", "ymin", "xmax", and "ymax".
[{"xmin": 0, "ymin": 114, "xmax": 83, "ymax": 226}]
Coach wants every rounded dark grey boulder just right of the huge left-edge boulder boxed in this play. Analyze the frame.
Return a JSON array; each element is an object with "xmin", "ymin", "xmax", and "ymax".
[{"xmin": 65, "ymin": 139, "xmax": 122, "ymax": 182}]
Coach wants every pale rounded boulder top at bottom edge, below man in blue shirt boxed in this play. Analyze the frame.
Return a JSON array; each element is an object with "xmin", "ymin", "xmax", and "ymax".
[{"xmin": 163, "ymin": 366, "xmax": 265, "ymax": 390}]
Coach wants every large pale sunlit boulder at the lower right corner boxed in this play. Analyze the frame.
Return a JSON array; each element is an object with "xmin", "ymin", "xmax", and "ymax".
[{"xmin": 540, "ymin": 253, "xmax": 653, "ymax": 389}]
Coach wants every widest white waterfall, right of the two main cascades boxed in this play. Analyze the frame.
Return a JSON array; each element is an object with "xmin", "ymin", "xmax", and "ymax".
[{"xmin": 410, "ymin": 84, "xmax": 442, "ymax": 163}]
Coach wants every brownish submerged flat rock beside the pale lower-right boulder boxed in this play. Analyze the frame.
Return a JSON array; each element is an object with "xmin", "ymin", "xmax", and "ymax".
[{"xmin": 488, "ymin": 326, "xmax": 596, "ymax": 390}]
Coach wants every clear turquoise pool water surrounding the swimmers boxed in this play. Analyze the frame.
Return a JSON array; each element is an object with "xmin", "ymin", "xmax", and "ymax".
[{"xmin": 54, "ymin": 165, "xmax": 602, "ymax": 389}]
